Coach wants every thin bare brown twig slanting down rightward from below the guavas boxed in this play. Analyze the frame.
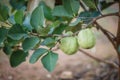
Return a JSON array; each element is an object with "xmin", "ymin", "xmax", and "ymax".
[{"xmin": 79, "ymin": 49, "xmax": 119, "ymax": 69}]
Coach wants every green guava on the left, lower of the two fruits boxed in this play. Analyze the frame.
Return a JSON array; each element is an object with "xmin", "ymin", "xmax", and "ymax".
[{"xmin": 60, "ymin": 37, "xmax": 79, "ymax": 55}]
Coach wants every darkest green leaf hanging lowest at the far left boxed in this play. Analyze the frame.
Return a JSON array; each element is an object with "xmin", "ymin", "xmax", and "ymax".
[{"xmin": 10, "ymin": 50, "xmax": 28, "ymax": 67}]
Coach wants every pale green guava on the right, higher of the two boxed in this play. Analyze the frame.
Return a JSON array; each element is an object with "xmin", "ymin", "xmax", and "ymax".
[{"xmin": 78, "ymin": 29, "xmax": 96, "ymax": 49}]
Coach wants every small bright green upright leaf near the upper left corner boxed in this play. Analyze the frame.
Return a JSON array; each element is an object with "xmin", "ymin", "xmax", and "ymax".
[{"xmin": 14, "ymin": 10, "xmax": 24, "ymax": 24}]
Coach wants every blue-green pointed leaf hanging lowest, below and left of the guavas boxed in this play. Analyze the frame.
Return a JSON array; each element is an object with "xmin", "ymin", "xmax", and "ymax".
[{"xmin": 41, "ymin": 52, "xmax": 58, "ymax": 72}]
